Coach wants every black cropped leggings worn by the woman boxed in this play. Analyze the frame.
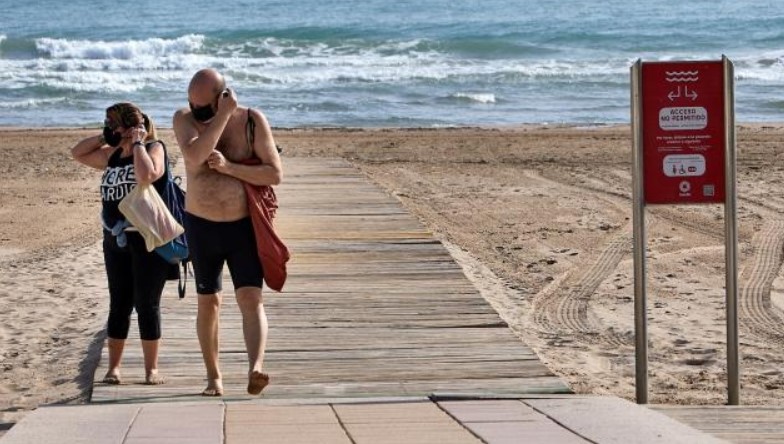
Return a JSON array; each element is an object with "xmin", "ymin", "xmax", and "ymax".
[{"xmin": 103, "ymin": 231, "xmax": 169, "ymax": 341}]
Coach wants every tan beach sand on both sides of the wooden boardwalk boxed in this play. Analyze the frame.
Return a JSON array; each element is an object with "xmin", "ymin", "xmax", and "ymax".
[{"xmin": 0, "ymin": 124, "xmax": 784, "ymax": 433}]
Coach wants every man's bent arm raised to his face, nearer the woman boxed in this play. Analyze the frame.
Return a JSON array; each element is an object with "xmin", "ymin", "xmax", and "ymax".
[{"xmin": 172, "ymin": 109, "xmax": 231, "ymax": 166}]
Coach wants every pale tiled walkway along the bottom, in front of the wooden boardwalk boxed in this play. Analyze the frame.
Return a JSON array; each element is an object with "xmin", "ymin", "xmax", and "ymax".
[{"xmin": 0, "ymin": 396, "xmax": 722, "ymax": 444}]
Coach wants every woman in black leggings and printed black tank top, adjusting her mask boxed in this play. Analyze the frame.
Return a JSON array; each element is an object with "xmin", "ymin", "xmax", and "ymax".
[{"xmin": 71, "ymin": 103, "xmax": 170, "ymax": 384}]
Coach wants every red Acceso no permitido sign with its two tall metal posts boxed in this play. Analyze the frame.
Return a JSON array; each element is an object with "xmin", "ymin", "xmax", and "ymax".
[{"xmin": 631, "ymin": 57, "xmax": 740, "ymax": 405}]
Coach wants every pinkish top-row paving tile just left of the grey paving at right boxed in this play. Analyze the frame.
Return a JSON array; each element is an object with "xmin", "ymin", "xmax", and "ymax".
[{"xmin": 438, "ymin": 399, "xmax": 550, "ymax": 423}]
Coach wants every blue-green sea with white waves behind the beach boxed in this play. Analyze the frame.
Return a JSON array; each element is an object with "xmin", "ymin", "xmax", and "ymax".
[{"xmin": 0, "ymin": 0, "xmax": 784, "ymax": 128}]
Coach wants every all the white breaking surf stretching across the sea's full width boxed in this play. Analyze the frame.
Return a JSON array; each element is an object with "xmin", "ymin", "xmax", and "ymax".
[{"xmin": 0, "ymin": 41, "xmax": 784, "ymax": 97}]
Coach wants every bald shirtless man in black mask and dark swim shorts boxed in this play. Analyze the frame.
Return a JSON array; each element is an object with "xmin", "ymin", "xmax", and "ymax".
[{"xmin": 173, "ymin": 69, "xmax": 282, "ymax": 396}]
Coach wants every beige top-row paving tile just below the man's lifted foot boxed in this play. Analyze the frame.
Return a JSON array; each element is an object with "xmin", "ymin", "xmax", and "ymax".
[{"xmin": 226, "ymin": 404, "xmax": 339, "ymax": 425}]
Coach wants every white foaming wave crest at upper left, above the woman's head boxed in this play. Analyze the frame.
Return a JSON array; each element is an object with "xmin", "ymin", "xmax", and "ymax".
[{"xmin": 35, "ymin": 34, "xmax": 204, "ymax": 60}]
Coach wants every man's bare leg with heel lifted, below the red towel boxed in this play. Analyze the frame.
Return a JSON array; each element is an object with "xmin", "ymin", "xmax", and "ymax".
[{"xmin": 237, "ymin": 287, "xmax": 269, "ymax": 395}]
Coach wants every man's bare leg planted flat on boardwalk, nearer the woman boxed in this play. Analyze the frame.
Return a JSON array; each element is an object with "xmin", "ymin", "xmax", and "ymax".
[{"xmin": 196, "ymin": 293, "xmax": 223, "ymax": 396}]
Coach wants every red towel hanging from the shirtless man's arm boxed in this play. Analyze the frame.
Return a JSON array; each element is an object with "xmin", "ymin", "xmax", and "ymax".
[{"xmin": 243, "ymin": 162, "xmax": 291, "ymax": 291}]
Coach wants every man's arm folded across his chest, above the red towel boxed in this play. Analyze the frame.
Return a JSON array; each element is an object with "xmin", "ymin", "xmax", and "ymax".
[{"xmin": 207, "ymin": 109, "xmax": 283, "ymax": 185}]
